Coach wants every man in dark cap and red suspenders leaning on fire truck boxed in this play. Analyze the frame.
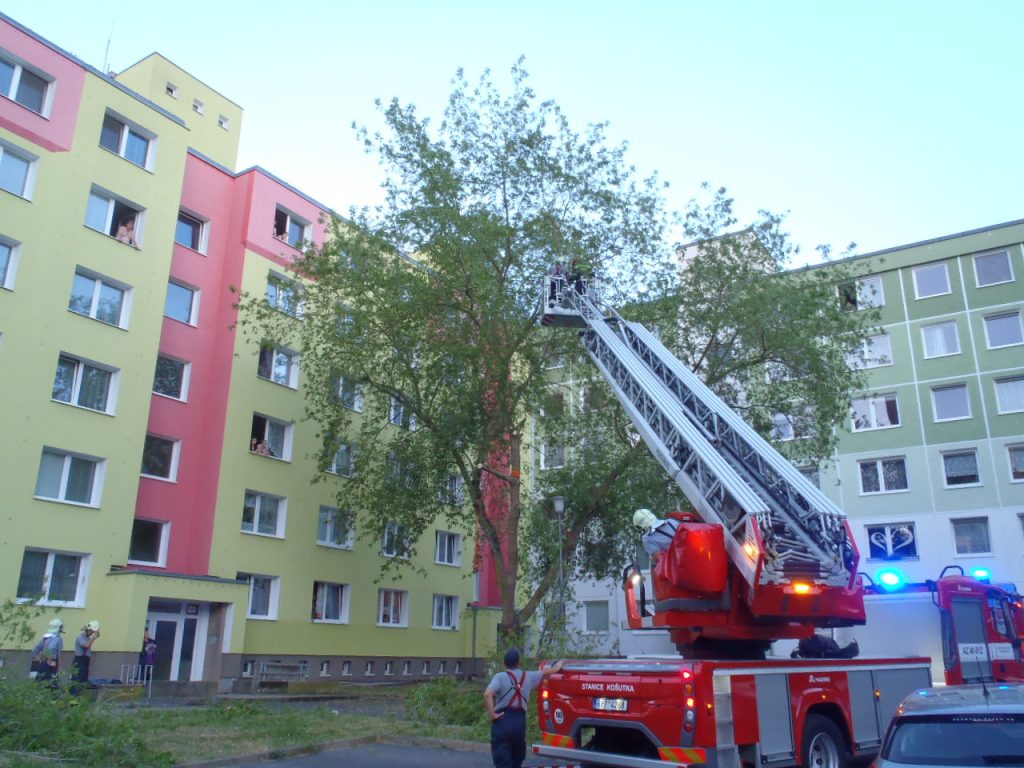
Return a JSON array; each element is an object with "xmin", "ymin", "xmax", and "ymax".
[{"xmin": 483, "ymin": 648, "xmax": 564, "ymax": 768}]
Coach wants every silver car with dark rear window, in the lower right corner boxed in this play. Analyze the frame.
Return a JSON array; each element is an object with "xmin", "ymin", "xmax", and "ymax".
[{"xmin": 872, "ymin": 683, "xmax": 1024, "ymax": 768}]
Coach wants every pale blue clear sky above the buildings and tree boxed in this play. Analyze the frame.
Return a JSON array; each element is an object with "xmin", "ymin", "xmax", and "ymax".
[{"xmin": 0, "ymin": 0, "xmax": 1024, "ymax": 265}]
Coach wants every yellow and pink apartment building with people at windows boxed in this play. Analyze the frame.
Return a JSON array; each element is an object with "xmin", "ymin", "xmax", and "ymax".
[{"xmin": 0, "ymin": 15, "xmax": 482, "ymax": 688}]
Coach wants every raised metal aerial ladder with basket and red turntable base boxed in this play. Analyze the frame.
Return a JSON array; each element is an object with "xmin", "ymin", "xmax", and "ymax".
[{"xmin": 542, "ymin": 275, "xmax": 864, "ymax": 658}]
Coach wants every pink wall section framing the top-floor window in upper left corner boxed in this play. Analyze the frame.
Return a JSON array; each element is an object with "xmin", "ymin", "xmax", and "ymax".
[{"xmin": 0, "ymin": 19, "xmax": 85, "ymax": 152}]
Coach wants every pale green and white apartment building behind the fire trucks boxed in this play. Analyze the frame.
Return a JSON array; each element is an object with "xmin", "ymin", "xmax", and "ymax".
[{"xmin": 561, "ymin": 221, "xmax": 1024, "ymax": 657}]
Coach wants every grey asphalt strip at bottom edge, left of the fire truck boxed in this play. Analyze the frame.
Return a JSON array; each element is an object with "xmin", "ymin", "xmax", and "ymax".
[{"xmin": 229, "ymin": 744, "xmax": 566, "ymax": 768}]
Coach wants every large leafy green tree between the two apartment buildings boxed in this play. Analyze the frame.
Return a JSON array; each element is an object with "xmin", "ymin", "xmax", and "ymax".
[{"xmin": 243, "ymin": 62, "xmax": 872, "ymax": 647}]
